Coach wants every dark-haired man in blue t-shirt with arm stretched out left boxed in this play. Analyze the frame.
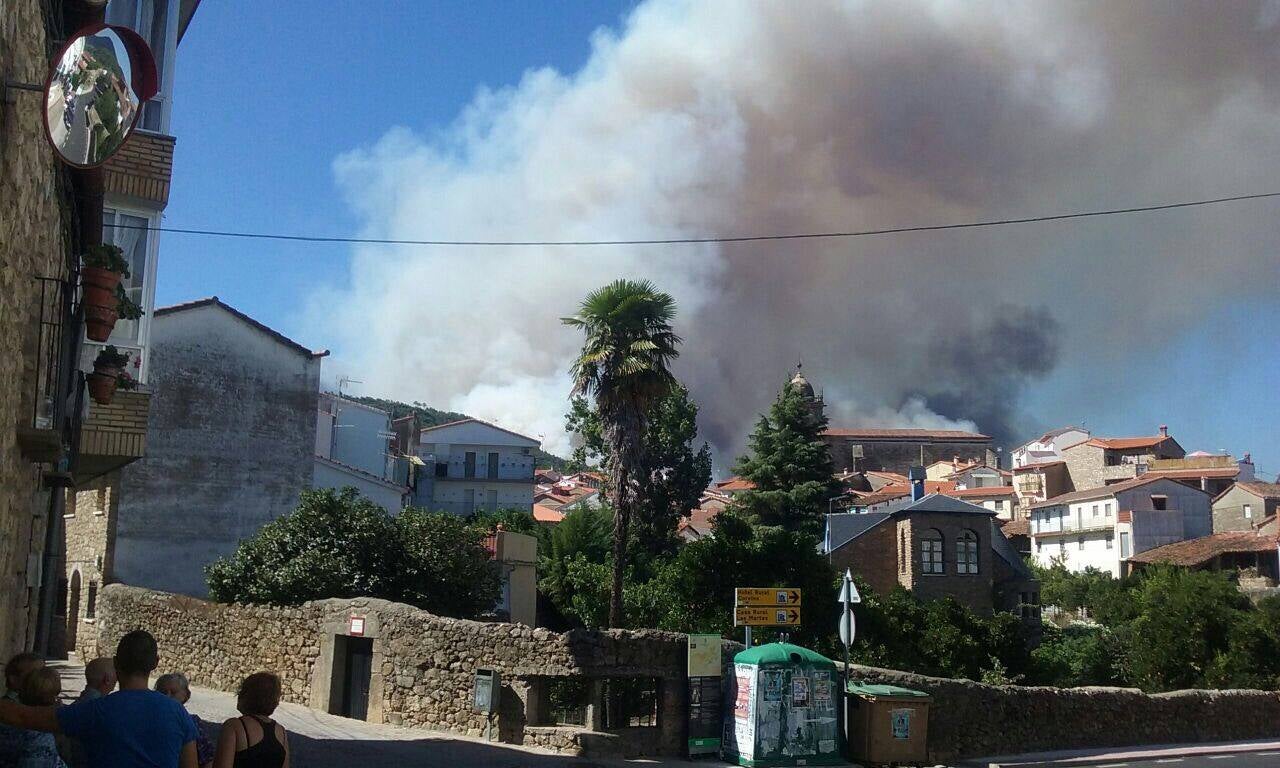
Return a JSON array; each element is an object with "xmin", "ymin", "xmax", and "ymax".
[{"xmin": 0, "ymin": 630, "xmax": 198, "ymax": 768}]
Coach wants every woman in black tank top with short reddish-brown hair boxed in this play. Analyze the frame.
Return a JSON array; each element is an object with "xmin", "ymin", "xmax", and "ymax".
[{"xmin": 214, "ymin": 672, "xmax": 289, "ymax": 768}]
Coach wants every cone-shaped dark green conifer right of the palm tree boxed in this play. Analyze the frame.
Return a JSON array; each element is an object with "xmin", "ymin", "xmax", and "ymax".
[{"xmin": 733, "ymin": 383, "xmax": 840, "ymax": 534}]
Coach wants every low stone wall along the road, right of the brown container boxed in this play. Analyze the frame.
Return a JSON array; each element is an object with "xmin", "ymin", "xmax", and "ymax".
[{"xmin": 852, "ymin": 666, "xmax": 1280, "ymax": 762}]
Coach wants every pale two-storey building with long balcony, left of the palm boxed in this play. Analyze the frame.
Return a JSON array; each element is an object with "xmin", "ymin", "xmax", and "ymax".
[{"xmin": 413, "ymin": 419, "xmax": 540, "ymax": 516}]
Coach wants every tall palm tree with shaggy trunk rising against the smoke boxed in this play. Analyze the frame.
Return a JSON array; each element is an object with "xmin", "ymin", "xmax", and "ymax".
[{"xmin": 562, "ymin": 280, "xmax": 680, "ymax": 627}]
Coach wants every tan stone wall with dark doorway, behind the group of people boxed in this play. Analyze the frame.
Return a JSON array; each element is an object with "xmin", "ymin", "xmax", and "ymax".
[{"xmin": 90, "ymin": 584, "xmax": 686, "ymax": 755}]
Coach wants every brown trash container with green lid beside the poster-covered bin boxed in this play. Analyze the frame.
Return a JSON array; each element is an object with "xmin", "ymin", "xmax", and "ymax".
[{"xmin": 845, "ymin": 682, "xmax": 933, "ymax": 765}]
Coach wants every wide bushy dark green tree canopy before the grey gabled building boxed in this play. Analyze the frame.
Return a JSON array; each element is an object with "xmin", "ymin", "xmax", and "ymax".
[{"xmin": 205, "ymin": 488, "xmax": 499, "ymax": 617}]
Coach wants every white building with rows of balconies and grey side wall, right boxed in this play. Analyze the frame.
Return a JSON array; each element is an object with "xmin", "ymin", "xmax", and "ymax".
[{"xmin": 1030, "ymin": 477, "xmax": 1213, "ymax": 576}]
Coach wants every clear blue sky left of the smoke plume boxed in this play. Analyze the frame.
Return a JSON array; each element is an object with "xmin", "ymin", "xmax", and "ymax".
[{"xmin": 156, "ymin": 0, "xmax": 632, "ymax": 321}]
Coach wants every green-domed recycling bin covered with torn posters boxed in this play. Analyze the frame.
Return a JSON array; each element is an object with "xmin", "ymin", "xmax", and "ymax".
[{"xmin": 722, "ymin": 643, "xmax": 844, "ymax": 767}]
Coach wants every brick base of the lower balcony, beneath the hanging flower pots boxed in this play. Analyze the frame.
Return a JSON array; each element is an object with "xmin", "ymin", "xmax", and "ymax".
[{"xmin": 74, "ymin": 389, "xmax": 151, "ymax": 484}]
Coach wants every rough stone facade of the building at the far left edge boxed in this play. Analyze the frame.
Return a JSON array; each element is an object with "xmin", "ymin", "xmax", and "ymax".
[{"xmin": 0, "ymin": 0, "xmax": 67, "ymax": 657}]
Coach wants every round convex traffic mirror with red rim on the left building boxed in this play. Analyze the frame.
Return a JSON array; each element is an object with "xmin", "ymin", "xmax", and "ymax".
[{"xmin": 45, "ymin": 24, "xmax": 157, "ymax": 168}]
